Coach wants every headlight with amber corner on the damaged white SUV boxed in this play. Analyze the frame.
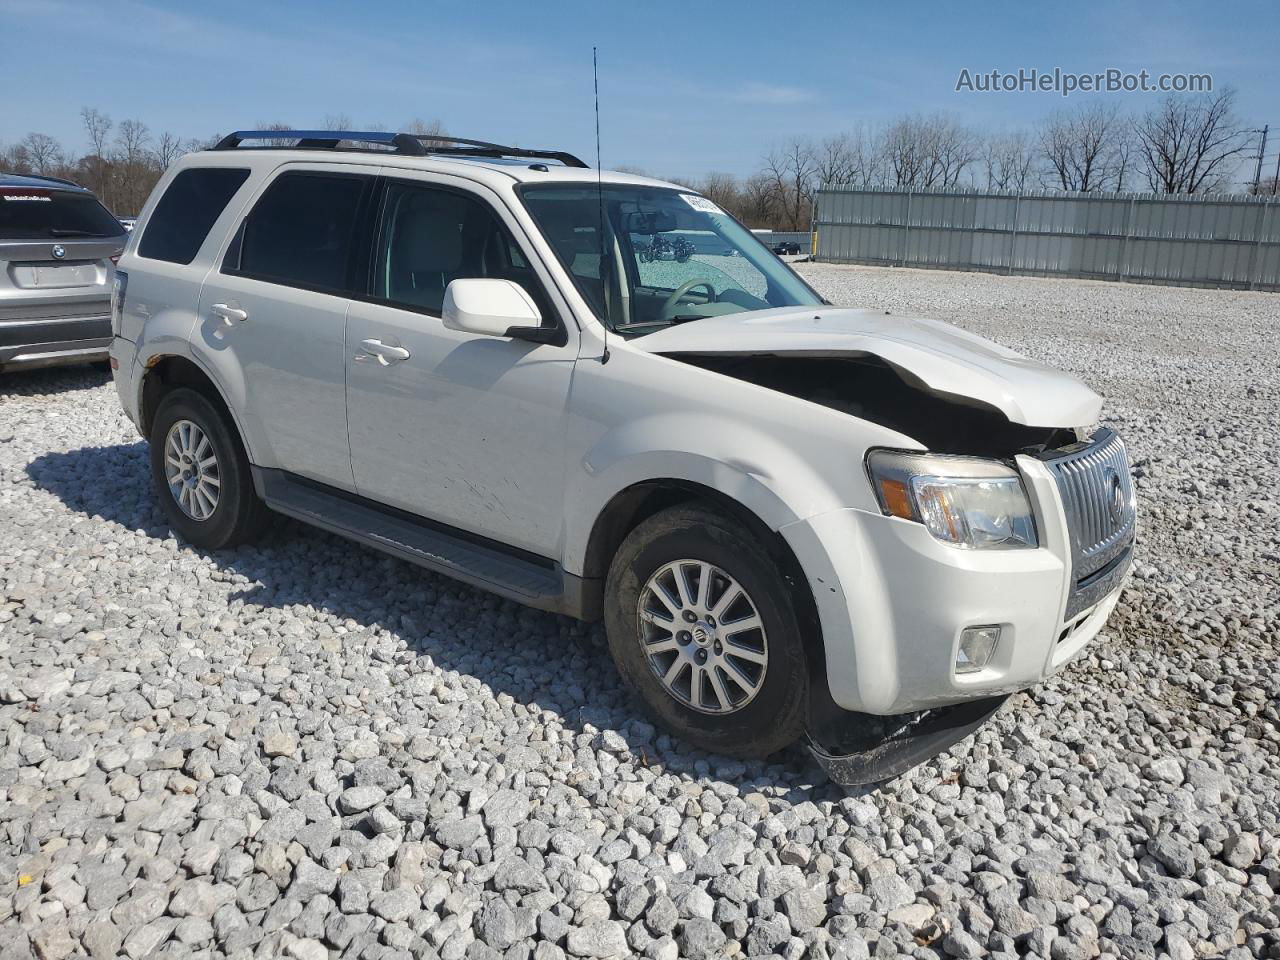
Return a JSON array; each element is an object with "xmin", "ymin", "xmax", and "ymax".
[{"xmin": 867, "ymin": 451, "xmax": 1038, "ymax": 550}]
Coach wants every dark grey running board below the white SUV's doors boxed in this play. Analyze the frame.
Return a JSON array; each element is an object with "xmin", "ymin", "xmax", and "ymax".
[{"xmin": 252, "ymin": 467, "xmax": 599, "ymax": 620}]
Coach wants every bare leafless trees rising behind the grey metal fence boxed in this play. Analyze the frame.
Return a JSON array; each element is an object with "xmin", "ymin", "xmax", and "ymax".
[{"xmin": 655, "ymin": 90, "xmax": 1264, "ymax": 230}]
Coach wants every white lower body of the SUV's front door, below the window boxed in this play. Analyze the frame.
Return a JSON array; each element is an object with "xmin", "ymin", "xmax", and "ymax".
[{"xmin": 347, "ymin": 302, "xmax": 573, "ymax": 557}]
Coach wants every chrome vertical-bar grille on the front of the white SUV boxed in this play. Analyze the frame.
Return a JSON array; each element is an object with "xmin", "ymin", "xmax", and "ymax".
[{"xmin": 1044, "ymin": 428, "xmax": 1137, "ymax": 617}]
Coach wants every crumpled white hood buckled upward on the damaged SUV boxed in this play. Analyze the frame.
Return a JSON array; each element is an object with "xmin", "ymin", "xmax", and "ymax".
[{"xmin": 631, "ymin": 307, "xmax": 1102, "ymax": 428}]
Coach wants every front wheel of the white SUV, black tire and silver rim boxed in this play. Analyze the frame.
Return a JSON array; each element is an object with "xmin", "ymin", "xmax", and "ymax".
[{"xmin": 604, "ymin": 507, "xmax": 809, "ymax": 758}]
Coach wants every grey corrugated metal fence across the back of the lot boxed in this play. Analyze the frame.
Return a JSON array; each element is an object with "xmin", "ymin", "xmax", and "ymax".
[{"xmin": 814, "ymin": 189, "xmax": 1280, "ymax": 291}]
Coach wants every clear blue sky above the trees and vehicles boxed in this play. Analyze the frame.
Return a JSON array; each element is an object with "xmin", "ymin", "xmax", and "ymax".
[{"xmin": 0, "ymin": 0, "xmax": 1280, "ymax": 183}]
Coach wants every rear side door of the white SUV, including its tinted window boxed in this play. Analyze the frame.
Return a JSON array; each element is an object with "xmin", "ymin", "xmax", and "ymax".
[{"xmin": 197, "ymin": 164, "xmax": 376, "ymax": 490}]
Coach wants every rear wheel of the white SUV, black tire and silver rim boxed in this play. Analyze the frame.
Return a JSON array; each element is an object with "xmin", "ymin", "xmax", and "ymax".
[{"xmin": 150, "ymin": 388, "xmax": 268, "ymax": 550}]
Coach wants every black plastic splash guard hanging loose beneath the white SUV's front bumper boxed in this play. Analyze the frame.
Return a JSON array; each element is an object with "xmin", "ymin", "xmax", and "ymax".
[{"xmin": 806, "ymin": 694, "xmax": 1010, "ymax": 787}]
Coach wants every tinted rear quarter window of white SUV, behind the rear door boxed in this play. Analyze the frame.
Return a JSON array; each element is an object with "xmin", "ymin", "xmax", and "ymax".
[{"xmin": 138, "ymin": 166, "xmax": 248, "ymax": 264}]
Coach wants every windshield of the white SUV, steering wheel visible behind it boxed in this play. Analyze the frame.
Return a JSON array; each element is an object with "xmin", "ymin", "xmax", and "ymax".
[{"xmin": 520, "ymin": 184, "xmax": 823, "ymax": 335}]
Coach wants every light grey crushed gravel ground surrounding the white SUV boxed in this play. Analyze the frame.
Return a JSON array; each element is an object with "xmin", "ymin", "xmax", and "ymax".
[{"xmin": 0, "ymin": 265, "xmax": 1280, "ymax": 960}]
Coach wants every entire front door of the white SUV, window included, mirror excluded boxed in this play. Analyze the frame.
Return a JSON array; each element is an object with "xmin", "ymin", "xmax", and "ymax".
[{"xmin": 347, "ymin": 180, "xmax": 577, "ymax": 557}]
